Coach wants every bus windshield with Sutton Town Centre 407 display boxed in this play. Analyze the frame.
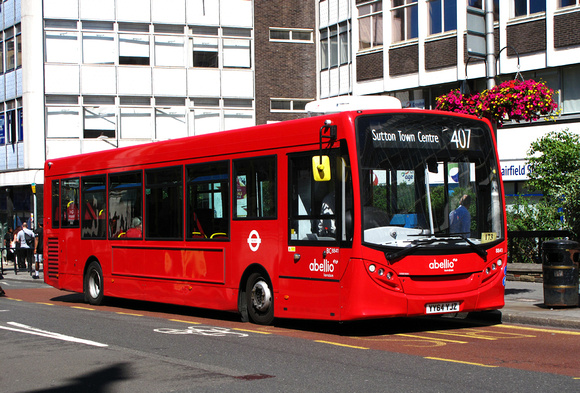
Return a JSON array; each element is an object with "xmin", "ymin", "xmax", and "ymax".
[{"xmin": 356, "ymin": 112, "xmax": 505, "ymax": 249}]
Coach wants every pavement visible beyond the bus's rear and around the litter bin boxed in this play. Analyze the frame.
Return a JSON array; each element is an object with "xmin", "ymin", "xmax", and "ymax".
[{"xmin": 0, "ymin": 263, "xmax": 580, "ymax": 330}]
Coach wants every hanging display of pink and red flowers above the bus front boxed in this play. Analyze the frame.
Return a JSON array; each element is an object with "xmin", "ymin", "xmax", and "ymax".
[{"xmin": 436, "ymin": 79, "xmax": 558, "ymax": 127}]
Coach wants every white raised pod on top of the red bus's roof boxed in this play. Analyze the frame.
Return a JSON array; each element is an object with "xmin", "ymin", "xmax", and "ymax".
[{"xmin": 306, "ymin": 96, "xmax": 402, "ymax": 116}]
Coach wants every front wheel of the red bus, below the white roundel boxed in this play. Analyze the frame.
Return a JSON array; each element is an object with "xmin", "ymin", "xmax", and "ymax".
[{"xmin": 246, "ymin": 273, "xmax": 274, "ymax": 325}]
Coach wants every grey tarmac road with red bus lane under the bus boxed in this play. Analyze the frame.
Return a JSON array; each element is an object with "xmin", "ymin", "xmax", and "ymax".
[{"xmin": 0, "ymin": 285, "xmax": 580, "ymax": 392}]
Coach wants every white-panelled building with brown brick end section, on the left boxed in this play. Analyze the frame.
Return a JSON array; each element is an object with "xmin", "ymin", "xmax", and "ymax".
[{"xmin": 0, "ymin": 0, "xmax": 316, "ymax": 230}]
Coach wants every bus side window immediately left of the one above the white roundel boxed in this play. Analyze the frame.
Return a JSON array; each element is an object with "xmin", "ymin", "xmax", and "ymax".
[{"xmin": 186, "ymin": 161, "xmax": 230, "ymax": 240}]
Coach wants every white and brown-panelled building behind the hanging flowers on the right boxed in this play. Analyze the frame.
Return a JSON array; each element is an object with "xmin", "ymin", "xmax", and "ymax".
[{"xmin": 317, "ymin": 0, "xmax": 580, "ymax": 199}]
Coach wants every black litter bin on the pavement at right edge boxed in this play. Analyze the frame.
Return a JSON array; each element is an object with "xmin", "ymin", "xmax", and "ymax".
[{"xmin": 542, "ymin": 240, "xmax": 580, "ymax": 307}]
